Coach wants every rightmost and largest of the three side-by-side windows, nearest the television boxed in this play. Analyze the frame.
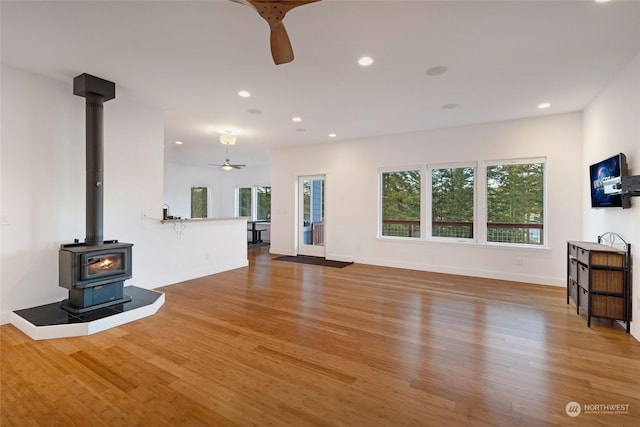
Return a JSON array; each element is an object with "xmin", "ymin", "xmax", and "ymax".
[{"xmin": 487, "ymin": 159, "xmax": 545, "ymax": 245}]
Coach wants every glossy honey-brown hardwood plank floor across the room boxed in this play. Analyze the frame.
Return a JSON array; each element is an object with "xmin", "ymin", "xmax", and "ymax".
[{"xmin": 0, "ymin": 248, "xmax": 640, "ymax": 427}]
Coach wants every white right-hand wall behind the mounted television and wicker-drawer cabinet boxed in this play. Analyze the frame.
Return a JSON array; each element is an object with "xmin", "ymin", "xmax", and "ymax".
[{"xmin": 581, "ymin": 54, "xmax": 640, "ymax": 339}]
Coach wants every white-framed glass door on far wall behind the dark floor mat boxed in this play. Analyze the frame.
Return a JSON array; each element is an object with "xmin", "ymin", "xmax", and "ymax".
[{"xmin": 298, "ymin": 175, "xmax": 325, "ymax": 257}]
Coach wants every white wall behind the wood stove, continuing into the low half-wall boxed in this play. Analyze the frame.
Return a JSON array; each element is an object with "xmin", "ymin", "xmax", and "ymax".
[{"xmin": 0, "ymin": 65, "xmax": 247, "ymax": 323}]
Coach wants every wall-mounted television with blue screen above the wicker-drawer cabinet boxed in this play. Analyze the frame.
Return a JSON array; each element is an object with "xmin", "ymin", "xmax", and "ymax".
[{"xmin": 589, "ymin": 153, "xmax": 631, "ymax": 208}]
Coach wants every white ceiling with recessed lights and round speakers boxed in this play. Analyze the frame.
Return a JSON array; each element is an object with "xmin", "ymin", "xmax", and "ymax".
[{"xmin": 0, "ymin": 0, "xmax": 640, "ymax": 166}]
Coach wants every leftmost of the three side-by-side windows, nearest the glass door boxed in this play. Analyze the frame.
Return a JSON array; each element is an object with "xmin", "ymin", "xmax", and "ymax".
[{"xmin": 380, "ymin": 170, "xmax": 421, "ymax": 238}]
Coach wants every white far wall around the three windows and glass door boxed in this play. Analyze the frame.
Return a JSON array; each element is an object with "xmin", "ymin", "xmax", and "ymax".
[{"xmin": 271, "ymin": 113, "xmax": 583, "ymax": 286}]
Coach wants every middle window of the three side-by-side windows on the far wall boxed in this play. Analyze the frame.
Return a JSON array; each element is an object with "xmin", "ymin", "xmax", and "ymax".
[{"xmin": 431, "ymin": 166, "xmax": 475, "ymax": 239}]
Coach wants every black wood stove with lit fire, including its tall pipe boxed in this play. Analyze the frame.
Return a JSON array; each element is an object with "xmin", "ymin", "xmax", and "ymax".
[{"xmin": 58, "ymin": 74, "xmax": 133, "ymax": 314}]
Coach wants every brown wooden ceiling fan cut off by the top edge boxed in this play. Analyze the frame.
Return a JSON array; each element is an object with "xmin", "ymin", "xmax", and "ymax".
[{"xmin": 231, "ymin": 0, "xmax": 320, "ymax": 65}]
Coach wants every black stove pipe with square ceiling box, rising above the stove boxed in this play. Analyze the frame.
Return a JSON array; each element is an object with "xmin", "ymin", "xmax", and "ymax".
[{"xmin": 73, "ymin": 73, "xmax": 115, "ymax": 245}]
